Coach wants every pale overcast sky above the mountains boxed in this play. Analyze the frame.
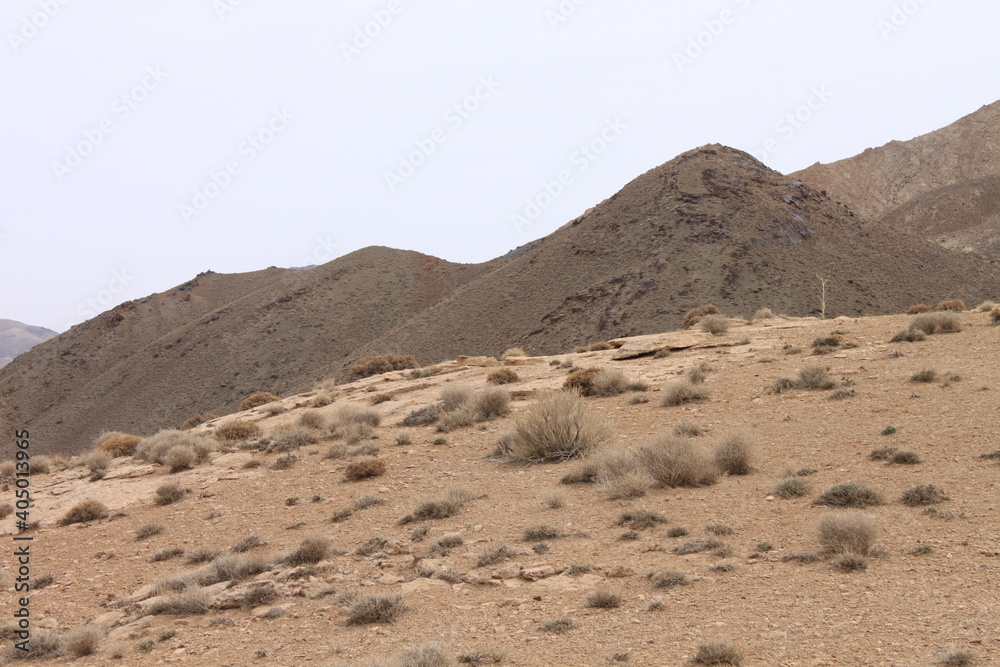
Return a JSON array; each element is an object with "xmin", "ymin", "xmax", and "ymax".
[{"xmin": 0, "ymin": 0, "xmax": 1000, "ymax": 331}]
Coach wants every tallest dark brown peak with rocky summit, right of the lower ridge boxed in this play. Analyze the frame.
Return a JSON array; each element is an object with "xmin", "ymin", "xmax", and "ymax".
[{"xmin": 354, "ymin": 146, "xmax": 1000, "ymax": 370}]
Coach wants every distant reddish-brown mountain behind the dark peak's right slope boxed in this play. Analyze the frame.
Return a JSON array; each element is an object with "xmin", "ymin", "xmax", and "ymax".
[{"xmin": 792, "ymin": 102, "xmax": 1000, "ymax": 256}]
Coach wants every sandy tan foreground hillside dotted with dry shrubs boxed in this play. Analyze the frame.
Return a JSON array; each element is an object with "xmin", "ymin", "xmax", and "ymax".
[{"xmin": 0, "ymin": 304, "xmax": 1000, "ymax": 667}]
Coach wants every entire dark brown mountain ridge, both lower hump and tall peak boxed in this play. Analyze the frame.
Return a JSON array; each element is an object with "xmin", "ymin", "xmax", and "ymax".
[{"xmin": 0, "ymin": 146, "xmax": 1000, "ymax": 451}]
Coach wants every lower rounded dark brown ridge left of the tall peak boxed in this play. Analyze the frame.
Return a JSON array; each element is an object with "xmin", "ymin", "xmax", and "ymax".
[{"xmin": 0, "ymin": 253, "xmax": 477, "ymax": 452}]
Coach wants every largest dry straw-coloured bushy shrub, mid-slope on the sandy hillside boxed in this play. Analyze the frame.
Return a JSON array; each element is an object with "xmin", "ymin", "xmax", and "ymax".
[{"xmin": 504, "ymin": 391, "xmax": 611, "ymax": 463}]
